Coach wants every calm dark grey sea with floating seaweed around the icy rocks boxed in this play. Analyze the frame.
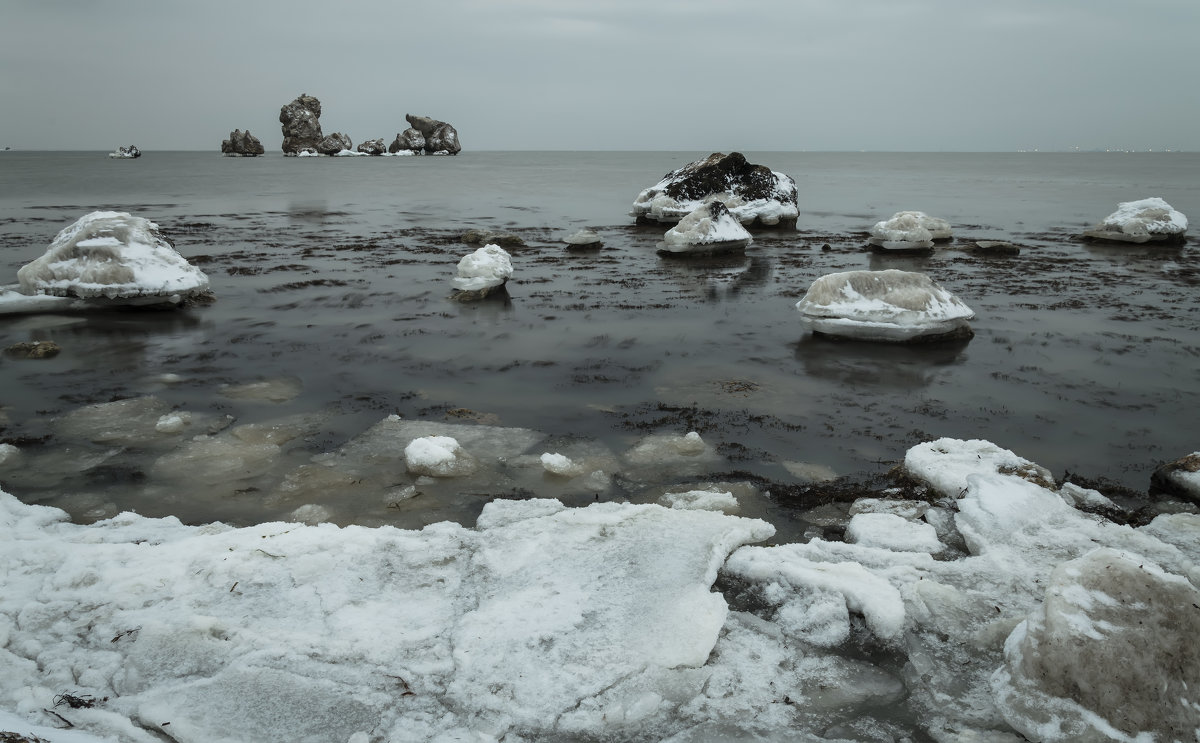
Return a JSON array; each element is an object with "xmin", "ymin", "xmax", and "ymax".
[{"xmin": 0, "ymin": 151, "xmax": 1200, "ymax": 521}]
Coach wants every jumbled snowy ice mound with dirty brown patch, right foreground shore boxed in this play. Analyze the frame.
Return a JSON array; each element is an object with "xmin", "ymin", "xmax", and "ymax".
[{"xmin": 718, "ymin": 439, "xmax": 1200, "ymax": 741}]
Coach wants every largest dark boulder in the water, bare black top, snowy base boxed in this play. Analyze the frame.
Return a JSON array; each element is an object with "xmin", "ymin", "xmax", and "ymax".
[{"xmin": 632, "ymin": 152, "xmax": 799, "ymax": 227}]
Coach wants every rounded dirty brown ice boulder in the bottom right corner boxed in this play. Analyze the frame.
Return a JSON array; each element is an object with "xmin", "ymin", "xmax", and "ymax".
[{"xmin": 992, "ymin": 549, "xmax": 1200, "ymax": 741}]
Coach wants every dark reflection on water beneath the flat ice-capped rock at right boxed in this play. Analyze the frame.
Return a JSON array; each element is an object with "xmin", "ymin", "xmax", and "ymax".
[{"xmin": 794, "ymin": 335, "xmax": 971, "ymax": 390}]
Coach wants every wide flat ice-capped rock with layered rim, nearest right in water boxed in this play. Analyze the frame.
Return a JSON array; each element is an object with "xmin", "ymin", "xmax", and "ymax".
[{"xmin": 796, "ymin": 269, "xmax": 974, "ymax": 342}]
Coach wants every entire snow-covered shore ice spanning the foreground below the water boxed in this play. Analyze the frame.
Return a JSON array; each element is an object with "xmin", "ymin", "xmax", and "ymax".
[{"xmin": 0, "ymin": 439, "xmax": 1200, "ymax": 743}]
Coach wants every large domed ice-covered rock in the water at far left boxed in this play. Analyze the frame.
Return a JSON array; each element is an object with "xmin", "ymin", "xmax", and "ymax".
[{"xmin": 17, "ymin": 211, "xmax": 209, "ymax": 301}]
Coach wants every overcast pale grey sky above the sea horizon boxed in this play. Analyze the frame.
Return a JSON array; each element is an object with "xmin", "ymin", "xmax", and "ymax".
[{"xmin": 0, "ymin": 0, "xmax": 1200, "ymax": 152}]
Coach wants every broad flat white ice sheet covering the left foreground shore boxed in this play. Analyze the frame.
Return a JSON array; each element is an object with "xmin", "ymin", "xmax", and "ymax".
[{"xmin": 0, "ymin": 493, "xmax": 774, "ymax": 743}]
